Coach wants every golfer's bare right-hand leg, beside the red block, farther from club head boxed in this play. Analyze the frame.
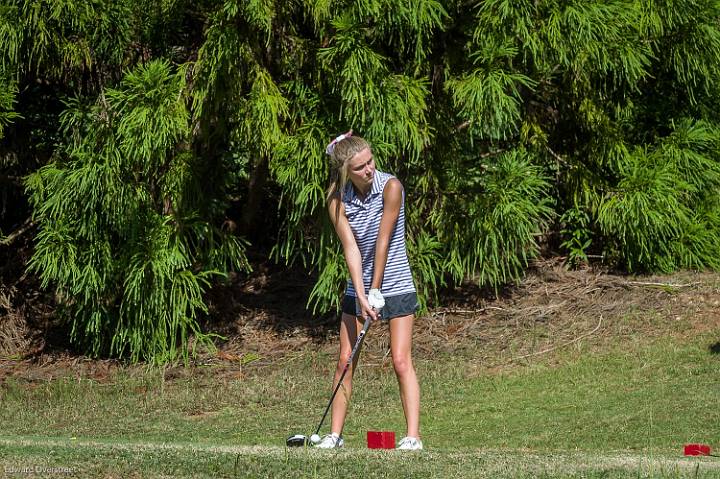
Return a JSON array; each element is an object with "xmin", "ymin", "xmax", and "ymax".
[{"xmin": 390, "ymin": 314, "xmax": 420, "ymax": 438}]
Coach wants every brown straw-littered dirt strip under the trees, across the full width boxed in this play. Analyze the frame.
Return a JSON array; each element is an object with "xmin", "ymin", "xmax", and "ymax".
[{"xmin": 0, "ymin": 261, "xmax": 720, "ymax": 381}]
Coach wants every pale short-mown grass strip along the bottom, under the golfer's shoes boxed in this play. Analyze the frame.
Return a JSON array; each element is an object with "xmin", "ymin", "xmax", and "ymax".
[{"xmin": 0, "ymin": 438, "xmax": 720, "ymax": 478}]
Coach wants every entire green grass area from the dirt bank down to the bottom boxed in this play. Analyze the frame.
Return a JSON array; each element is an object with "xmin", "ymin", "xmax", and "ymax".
[{"xmin": 0, "ymin": 318, "xmax": 720, "ymax": 478}]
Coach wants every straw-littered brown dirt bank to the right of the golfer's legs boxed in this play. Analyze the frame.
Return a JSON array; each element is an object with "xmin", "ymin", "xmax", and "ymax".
[{"xmin": 415, "ymin": 263, "xmax": 720, "ymax": 364}]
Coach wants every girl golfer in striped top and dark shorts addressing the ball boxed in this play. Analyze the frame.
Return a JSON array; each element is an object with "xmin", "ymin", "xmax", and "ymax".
[{"xmin": 317, "ymin": 130, "xmax": 422, "ymax": 450}]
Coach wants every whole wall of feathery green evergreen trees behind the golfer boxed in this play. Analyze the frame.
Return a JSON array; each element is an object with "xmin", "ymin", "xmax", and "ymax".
[{"xmin": 0, "ymin": 0, "xmax": 720, "ymax": 360}]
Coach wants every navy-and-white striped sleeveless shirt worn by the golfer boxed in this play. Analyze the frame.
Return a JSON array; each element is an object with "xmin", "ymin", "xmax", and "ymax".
[{"xmin": 342, "ymin": 170, "xmax": 415, "ymax": 297}]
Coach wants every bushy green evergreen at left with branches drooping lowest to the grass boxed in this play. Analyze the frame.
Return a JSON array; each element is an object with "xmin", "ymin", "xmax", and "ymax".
[{"xmin": 27, "ymin": 61, "xmax": 247, "ymax": 362}]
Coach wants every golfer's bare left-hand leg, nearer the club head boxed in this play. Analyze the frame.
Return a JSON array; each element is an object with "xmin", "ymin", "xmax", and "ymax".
[{"xmin": 330, "ymin": 313, "xmax": 363, "ymax": 435}]
